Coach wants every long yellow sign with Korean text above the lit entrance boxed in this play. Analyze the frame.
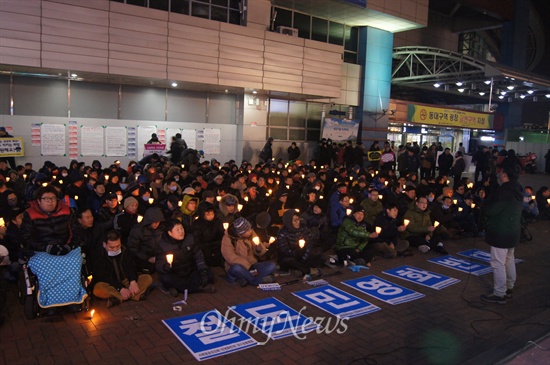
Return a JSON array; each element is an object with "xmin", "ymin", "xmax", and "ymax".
[{"xmin": 407, "ymin": 104, "xmax": 493, "ymax": 129}]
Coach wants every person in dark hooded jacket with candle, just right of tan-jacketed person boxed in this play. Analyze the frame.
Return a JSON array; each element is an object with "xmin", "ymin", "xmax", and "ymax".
[{"xmin": 277, "ymin": 209, "xmax": 323, "ymax": 276}]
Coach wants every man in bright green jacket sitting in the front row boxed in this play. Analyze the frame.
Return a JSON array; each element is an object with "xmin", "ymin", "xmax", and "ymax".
[{"xmin": 334, "ymin": 204, "xmax": 387, "ymax": 266}]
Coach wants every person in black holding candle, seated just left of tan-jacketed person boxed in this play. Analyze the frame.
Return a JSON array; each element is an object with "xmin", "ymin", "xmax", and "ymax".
[{"xmin": 155, "ymin": 219, "xmax": 216, "ymax": 296}]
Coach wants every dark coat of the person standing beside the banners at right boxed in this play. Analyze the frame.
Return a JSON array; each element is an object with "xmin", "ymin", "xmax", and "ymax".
[{"xmin": 485, "ymin": 180, "xmax": 523, "ymax": 248}]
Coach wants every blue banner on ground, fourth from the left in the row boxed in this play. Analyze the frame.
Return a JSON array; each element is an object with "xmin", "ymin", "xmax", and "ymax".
[{"xmin": 342, "ymin": 275, "xmax": 424, "ymax": 305}]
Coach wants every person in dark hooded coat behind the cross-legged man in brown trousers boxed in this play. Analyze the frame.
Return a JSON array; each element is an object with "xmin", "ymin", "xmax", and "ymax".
[{"xmin": 126, "ymin": 207, "xmax": 164, "ymax": 272}]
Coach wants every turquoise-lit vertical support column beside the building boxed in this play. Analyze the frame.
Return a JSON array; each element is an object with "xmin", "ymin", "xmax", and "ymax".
[{"xmin": 357, "ymin": 27, "xmax": 393, "ymax": 147}]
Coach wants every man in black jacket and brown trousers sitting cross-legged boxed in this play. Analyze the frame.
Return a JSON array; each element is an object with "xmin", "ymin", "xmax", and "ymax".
[{"xmin": 92, "ymin": 230, "xmax": 153, "ymax": 307}]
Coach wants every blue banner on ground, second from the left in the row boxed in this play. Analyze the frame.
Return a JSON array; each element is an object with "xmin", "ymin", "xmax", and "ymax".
[{"xmin": 229, "ymin": 298, "xmax": 319, "ymax": 340}]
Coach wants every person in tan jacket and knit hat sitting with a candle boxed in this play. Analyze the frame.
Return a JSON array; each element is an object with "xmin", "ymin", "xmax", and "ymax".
[{"xmin": 221, "ymin": 217, "xmax": 275, "ymax": 287}]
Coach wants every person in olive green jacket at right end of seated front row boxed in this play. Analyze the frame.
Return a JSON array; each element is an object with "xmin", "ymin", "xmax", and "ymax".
[{"xmin": 401, "ymin": 196, "xmax": 448, "ymax": 255}]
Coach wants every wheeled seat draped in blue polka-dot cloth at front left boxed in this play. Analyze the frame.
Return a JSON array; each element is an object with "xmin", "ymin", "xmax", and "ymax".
[{"xmin": 19, "ymin": 247, "xmax": 90, "ymax": 319}]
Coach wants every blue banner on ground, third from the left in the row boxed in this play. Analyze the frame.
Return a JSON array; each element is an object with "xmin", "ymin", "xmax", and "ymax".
[{"xmin": 292, "ymin": 285, "xmax": 380, "ymax": 318}]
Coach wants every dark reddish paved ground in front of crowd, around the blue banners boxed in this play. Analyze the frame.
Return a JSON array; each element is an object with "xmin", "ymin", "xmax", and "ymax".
[{"xmin": 0, "ymin": 175, "xmax": 550, "ymax": 365}]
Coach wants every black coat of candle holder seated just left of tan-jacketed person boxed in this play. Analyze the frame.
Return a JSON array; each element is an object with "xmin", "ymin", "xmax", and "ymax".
[{"xmin": 155, "ymin": 233, "xmax": 208, "ymax": 278}]
